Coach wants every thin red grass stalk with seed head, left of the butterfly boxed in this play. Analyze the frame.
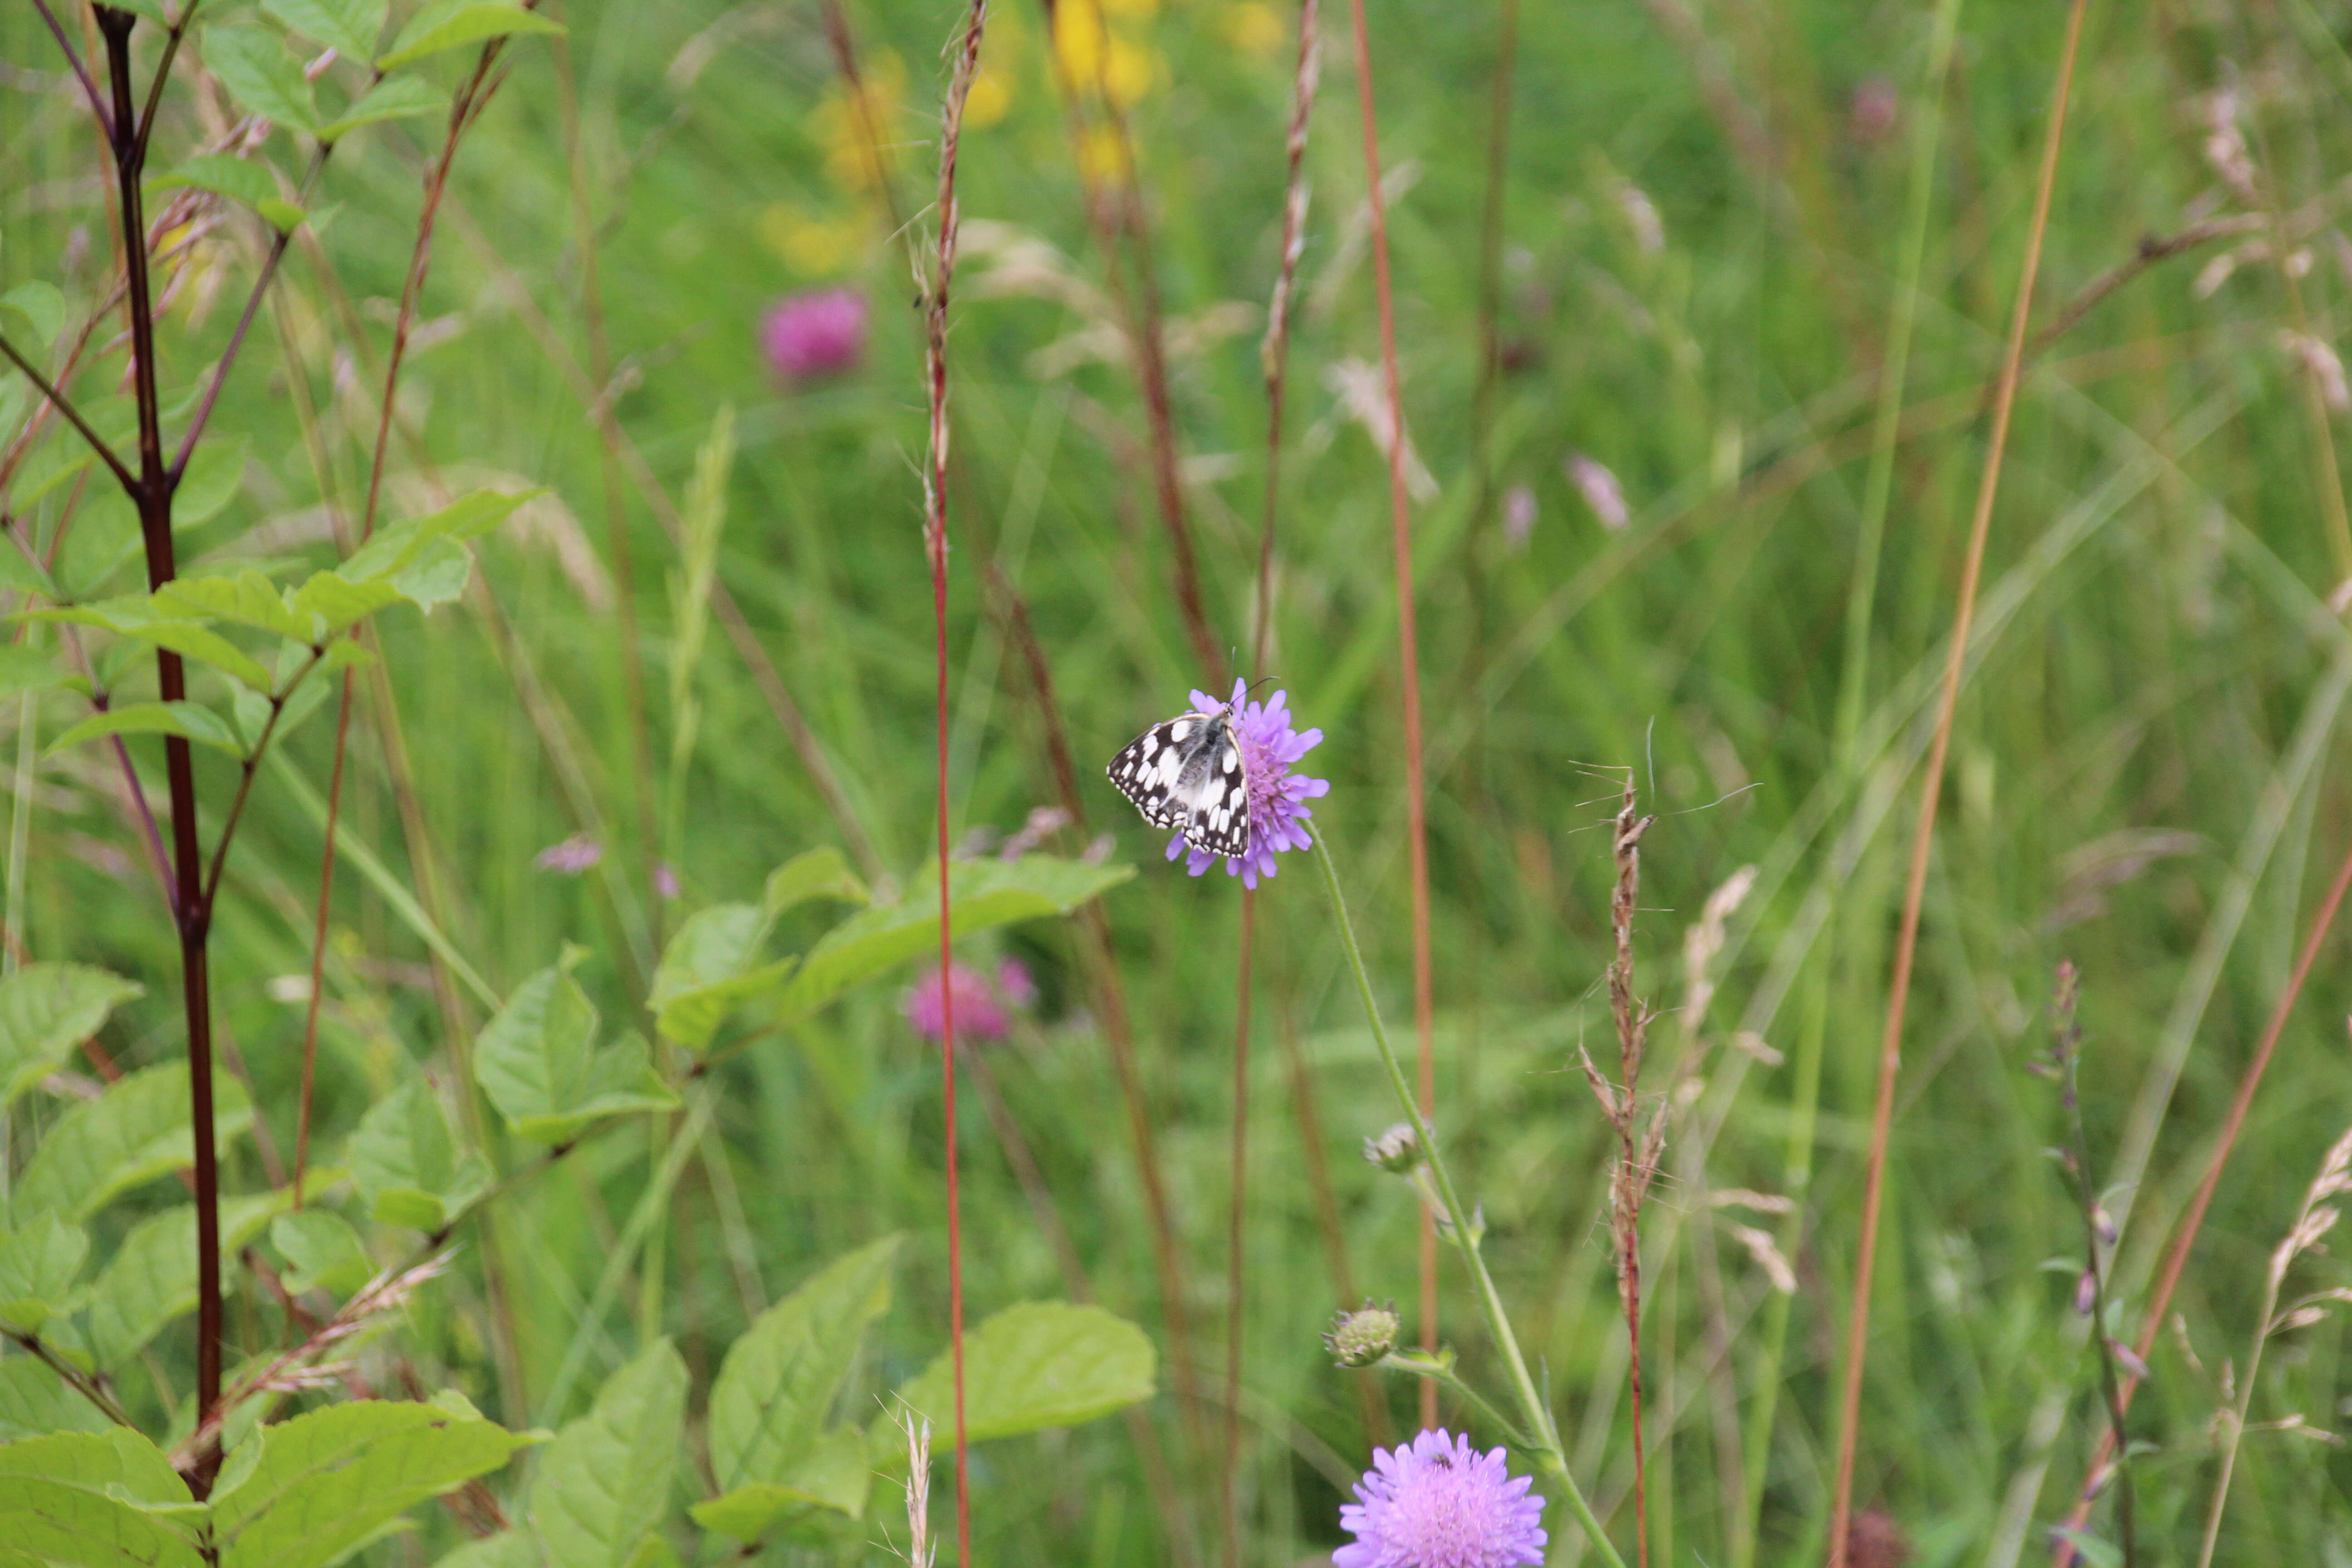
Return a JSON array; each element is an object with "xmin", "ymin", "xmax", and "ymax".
[{"xmin": 922, "ymin": 0, "xmax": 988, "ymax": 1568}]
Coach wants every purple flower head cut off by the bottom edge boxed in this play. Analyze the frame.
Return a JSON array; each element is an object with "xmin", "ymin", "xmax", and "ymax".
[{"xmin": 1331, "ymin": 1427, "xmax": 1545, "ymax": 1568}]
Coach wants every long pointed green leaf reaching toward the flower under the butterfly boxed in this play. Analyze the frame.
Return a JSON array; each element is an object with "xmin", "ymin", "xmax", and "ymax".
[{"xmin": 776, "ymin": 856, "xmax": 1136, "ymax": 1023}]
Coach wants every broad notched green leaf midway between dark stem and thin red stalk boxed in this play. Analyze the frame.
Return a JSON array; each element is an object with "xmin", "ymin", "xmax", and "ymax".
[{"xmin": 473, "ymin": 964, "xmax": 677, "ymax": 1145}]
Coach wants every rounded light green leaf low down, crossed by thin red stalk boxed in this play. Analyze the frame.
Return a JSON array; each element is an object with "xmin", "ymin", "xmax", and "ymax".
[{"xmin": 875, "ymin": 1303, "xmax": 1155, "ymax": 1443}]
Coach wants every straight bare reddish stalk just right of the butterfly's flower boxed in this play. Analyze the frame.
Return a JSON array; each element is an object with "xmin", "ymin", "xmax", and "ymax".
[{"xmin": 1348, "ymin": 0, "xmax": 1437, "ymax": 1427}]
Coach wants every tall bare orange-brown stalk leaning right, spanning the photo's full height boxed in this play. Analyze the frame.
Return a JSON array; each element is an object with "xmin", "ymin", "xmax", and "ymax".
[{"xmin": 1830, "ymin": 0, "xmax": 2086, "ymax": 1568}]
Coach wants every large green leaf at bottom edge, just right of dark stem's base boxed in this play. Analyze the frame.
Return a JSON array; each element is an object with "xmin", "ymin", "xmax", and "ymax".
[{"xmin": 212, "ymin": 1399, "xmax": 539, "ymax": 1568}]
